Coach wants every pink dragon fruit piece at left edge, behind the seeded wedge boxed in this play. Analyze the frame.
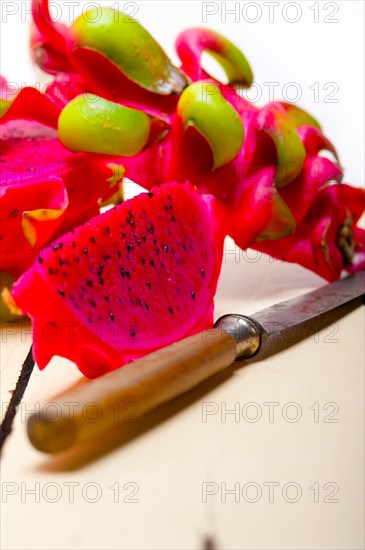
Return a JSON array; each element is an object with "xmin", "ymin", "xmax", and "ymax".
[{"xmin": 0, "ymin": 79, "xmax": 124, "ymax": 276}]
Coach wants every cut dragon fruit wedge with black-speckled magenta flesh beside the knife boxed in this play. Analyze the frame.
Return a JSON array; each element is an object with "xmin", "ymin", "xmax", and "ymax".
[{"xmin": 12, "ymin": 183, "xmax": 224, "ymax": 378}]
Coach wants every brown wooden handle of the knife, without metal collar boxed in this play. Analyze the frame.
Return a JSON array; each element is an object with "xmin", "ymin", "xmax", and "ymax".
[{"xmin": 28, "ymin": 328, "xmax": 237, "ymax": 453}]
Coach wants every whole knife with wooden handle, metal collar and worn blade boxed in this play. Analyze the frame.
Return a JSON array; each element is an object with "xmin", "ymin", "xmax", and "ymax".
[{"xmin": 27, "ymin": 271, "xmax": 365, "ymax": 453}]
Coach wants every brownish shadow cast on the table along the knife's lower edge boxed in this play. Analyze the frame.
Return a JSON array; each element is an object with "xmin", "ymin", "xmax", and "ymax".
[{"xmin": 37, "ymin": 298, "xmax": 362, "ymax": 472}]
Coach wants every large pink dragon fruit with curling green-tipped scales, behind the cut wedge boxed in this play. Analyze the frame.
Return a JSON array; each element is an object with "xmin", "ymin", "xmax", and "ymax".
[{"xmin": 21, "ymin": 4, "xmax": 364, "ymax": 286}]
